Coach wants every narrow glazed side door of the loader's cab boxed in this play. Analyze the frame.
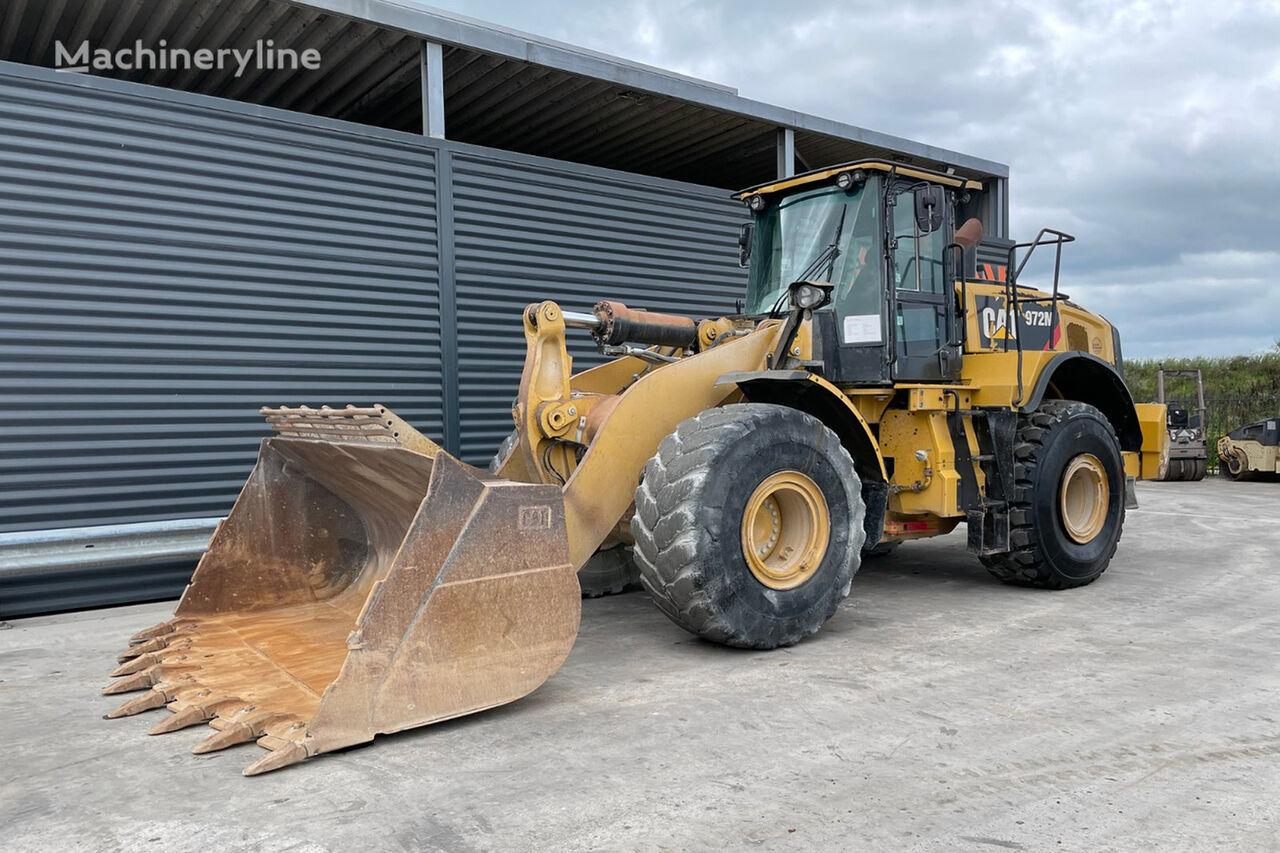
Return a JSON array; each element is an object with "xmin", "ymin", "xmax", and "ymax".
[{"xmin": 884, "ymin": 181, "xmax": 960, "ymax": 382}]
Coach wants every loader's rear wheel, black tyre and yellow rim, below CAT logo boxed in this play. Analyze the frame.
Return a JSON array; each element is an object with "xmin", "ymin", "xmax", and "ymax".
[{"xmin": 982, "ymin": 400, "xmax": 1125, "ymax": 589}]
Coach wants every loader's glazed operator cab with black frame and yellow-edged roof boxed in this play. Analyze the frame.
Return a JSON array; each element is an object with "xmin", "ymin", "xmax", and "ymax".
[{"xmin": 736, "ymin": 160, "xmax": 982, "ymax": 384}]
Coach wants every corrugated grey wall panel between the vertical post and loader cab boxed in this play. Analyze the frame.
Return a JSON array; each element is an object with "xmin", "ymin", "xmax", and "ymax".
[{"xmin": 452, "ymin": 152, "xmax": 746, "ymax": 464}]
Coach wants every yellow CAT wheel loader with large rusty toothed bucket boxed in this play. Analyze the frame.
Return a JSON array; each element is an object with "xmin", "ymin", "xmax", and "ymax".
[{"xmin": 105, "ymin": 160, "xmax": 1169, "ymax": 775}]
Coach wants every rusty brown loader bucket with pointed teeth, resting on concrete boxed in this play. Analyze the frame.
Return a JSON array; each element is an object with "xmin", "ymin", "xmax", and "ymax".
[{"xmin": 104, "ymin": 406, "xmax": 581, "ymax": 775}]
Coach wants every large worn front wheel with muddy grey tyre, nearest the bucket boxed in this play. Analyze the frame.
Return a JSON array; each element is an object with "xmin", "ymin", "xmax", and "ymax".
[{"xmin": 631, "ymin": 403, "xmax": 867, "ymax": 649}]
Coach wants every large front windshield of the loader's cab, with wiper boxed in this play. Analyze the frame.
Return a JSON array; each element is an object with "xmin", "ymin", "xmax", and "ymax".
[{"xmin": 746, "ymin": 181, "xmax": 879, "ymax": 314}]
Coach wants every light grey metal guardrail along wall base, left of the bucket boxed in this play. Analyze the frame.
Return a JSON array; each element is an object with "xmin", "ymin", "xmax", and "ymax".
[{"xmin": 0, "ymin": 519, "xmax": 221, "ymax": 578}]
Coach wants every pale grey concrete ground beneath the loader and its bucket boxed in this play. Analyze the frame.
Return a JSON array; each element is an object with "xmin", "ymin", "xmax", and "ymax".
[{"xmin": 0, "ymin": 480, "xmax": 1280, "ymax": 852}]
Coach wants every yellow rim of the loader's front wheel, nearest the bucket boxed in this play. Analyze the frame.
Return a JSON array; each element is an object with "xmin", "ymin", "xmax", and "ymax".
[{"xmin": 742, "ymin": 471, "xmax": 831, "ymax": 589}]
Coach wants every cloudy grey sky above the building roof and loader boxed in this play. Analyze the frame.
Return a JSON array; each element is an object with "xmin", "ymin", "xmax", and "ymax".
[{"xmin": 429, "ymin": 0, "xmax": 1280, "ymax": 357}]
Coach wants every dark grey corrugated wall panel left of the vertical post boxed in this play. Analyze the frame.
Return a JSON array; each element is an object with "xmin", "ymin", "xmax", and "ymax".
[{"xmin": 0, "ymin": 69, "xmax": 443, "ymax": 532}]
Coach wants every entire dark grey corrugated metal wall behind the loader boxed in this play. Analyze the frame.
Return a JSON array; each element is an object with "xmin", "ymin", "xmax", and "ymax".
[{"xmin": 0, "ymin": 63, "xmax": 744, "ymax": 615}]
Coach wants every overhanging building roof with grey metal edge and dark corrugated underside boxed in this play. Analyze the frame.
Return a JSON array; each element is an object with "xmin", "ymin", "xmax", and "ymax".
[{"xmin": 0, "ymin": 0, "xmax": 1009, "ymax": 188}]
